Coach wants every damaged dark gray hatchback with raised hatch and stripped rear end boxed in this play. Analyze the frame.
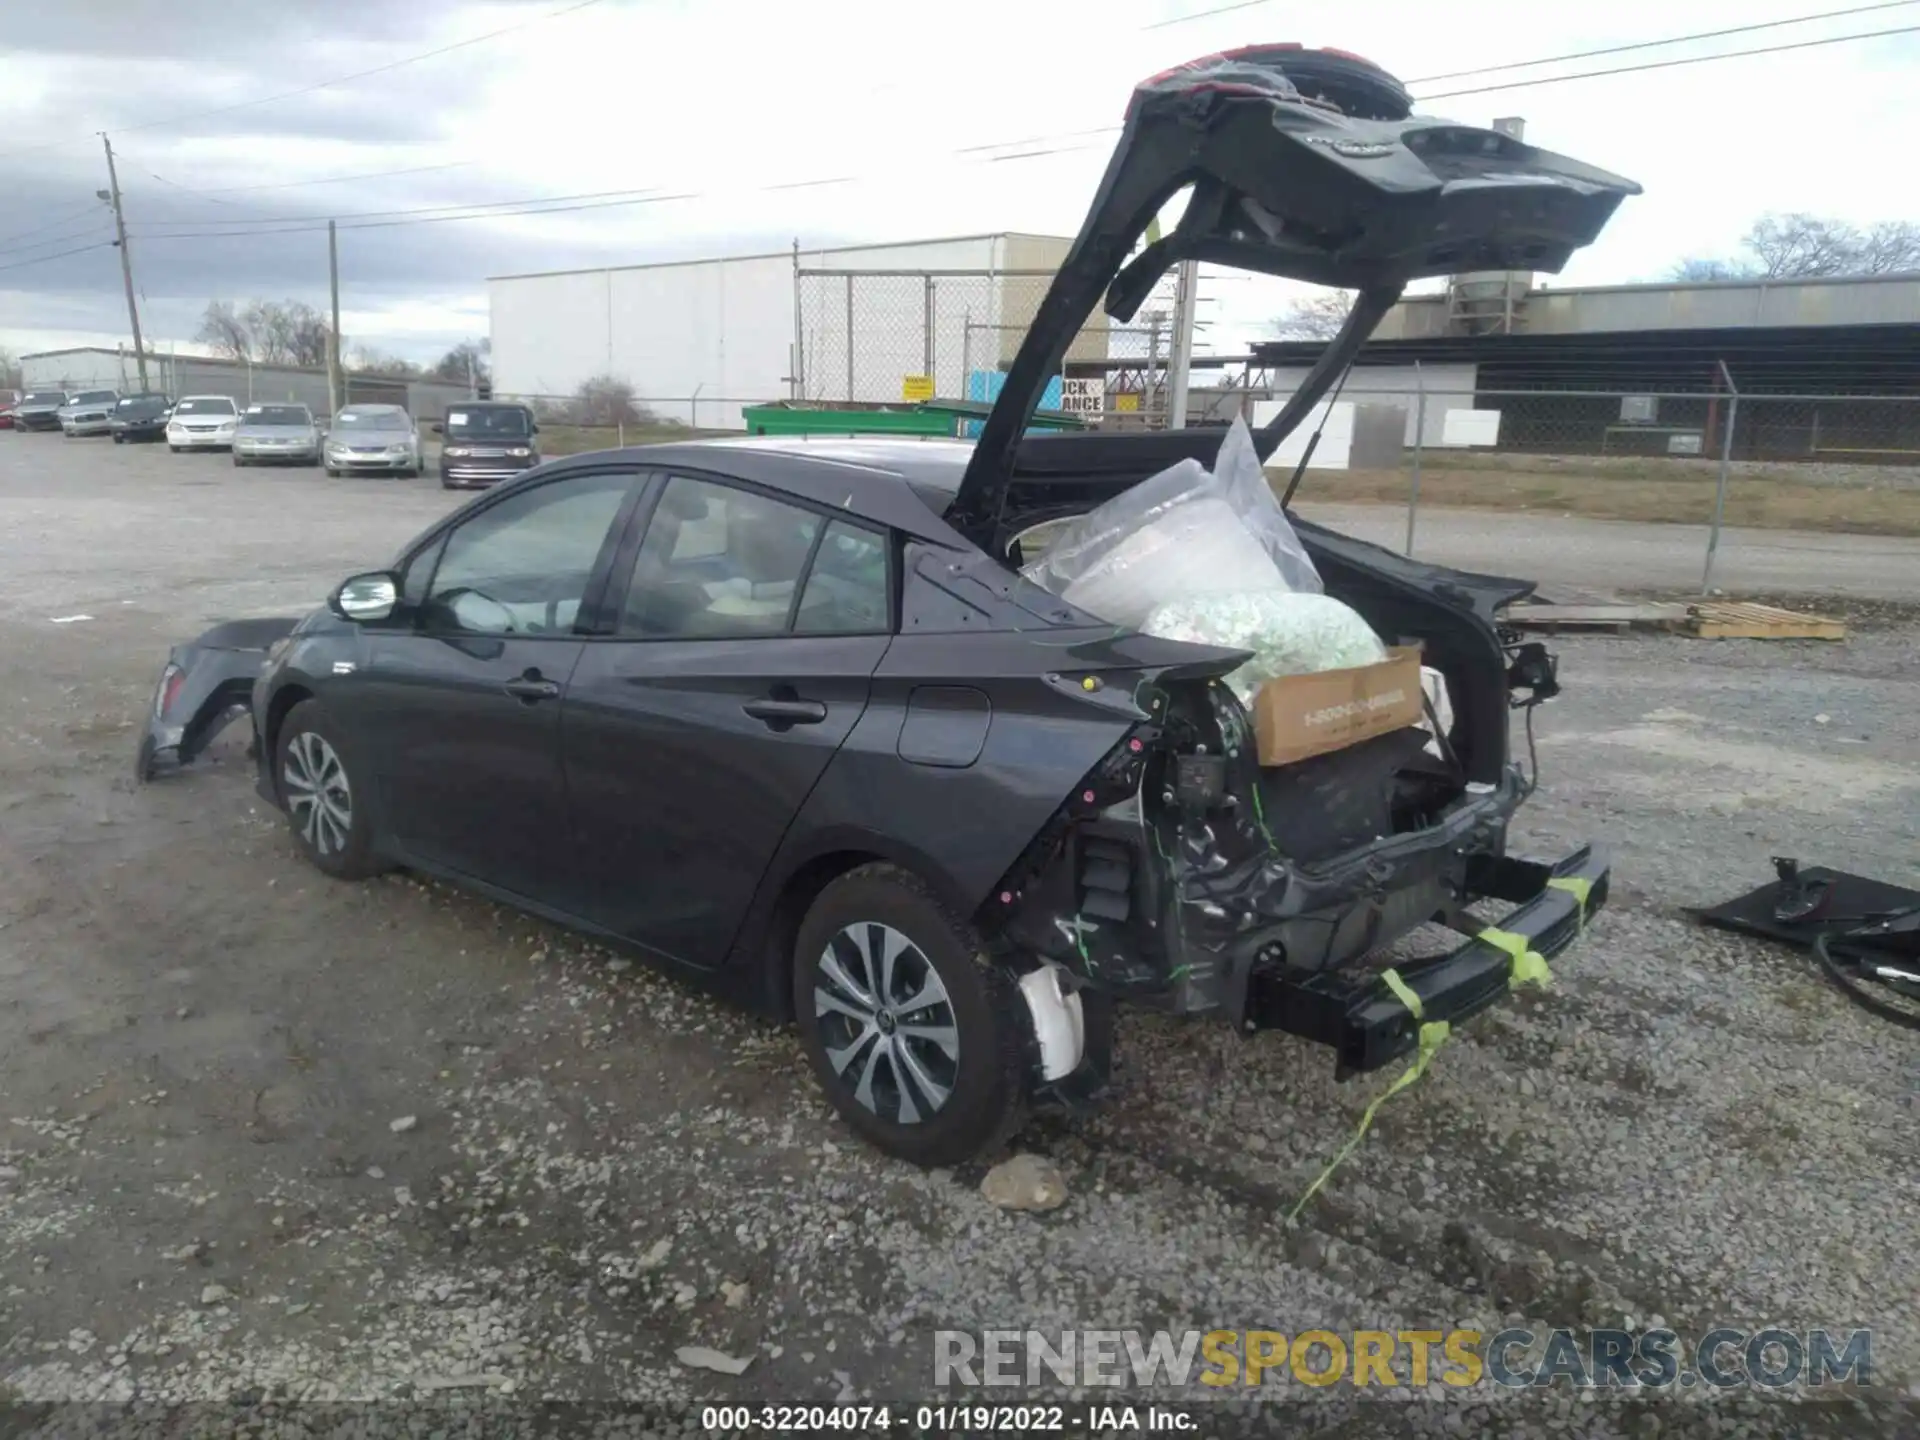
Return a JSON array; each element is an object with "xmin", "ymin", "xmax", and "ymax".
[{"xmin": 142, "ymin": 46, "xmax": 1636, "ymax": 1165}]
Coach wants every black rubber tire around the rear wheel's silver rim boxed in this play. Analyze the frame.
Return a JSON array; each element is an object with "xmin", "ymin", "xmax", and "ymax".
[{"xmin": 793, "ymin": 864, "xmax": 1035, "ymax": 1165}]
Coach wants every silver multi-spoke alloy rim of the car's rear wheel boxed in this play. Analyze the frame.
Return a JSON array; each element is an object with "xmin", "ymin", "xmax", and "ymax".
[{"xmin": 814, "ymin": 922, "xmax": 960, "ymax": 1125}]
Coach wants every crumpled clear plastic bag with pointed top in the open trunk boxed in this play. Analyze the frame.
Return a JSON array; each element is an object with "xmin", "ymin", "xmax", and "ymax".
[{"xmin": 1021, "ymin": 410, "xmax": 1323, "ymax": 628}]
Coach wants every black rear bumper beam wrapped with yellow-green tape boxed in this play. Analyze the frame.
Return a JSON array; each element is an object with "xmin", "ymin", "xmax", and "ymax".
[{"xmin": 1246, "ymin": 845, "xmax": 1611, "ymax": 1077}]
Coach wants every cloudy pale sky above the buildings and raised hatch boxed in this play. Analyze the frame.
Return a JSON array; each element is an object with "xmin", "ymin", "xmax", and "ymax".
[{"xmin": 0, "ymin": 0, "xmax": 1920, "ymax": 361}]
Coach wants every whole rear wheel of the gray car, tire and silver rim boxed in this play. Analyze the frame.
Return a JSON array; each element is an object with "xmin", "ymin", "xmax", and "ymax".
[{"xmin": 793, "ymin": 864, "xmax": 1033, "ymax": 1165}]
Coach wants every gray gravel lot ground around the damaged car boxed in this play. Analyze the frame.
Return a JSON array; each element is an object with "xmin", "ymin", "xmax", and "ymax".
[{"xmin": 0, "ymin": 436, "xmax": 1920, "ymax": 1434}]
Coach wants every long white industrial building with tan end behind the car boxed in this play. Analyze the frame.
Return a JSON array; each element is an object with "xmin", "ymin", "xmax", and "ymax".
[{"xmin": 488, "ymin": 232, "xmax": 1106, "ymax": 428}]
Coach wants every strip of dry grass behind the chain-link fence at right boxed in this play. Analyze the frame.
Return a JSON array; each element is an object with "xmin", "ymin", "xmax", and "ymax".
[{"xmin": 1300, "ymin": 465, "xmax": 1920, "ymax": 536}]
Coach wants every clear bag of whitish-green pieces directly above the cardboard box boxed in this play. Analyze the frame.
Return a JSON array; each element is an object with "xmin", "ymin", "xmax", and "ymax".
[{"xmin": 1140, "ymin": 589, "xmax": 1386, "ymax": 705}]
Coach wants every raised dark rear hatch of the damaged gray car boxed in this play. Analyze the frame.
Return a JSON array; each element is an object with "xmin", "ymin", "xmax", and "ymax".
[{"xmin": 947, "ymin": 44, "xmax": 1640, "ymax": 555}]
